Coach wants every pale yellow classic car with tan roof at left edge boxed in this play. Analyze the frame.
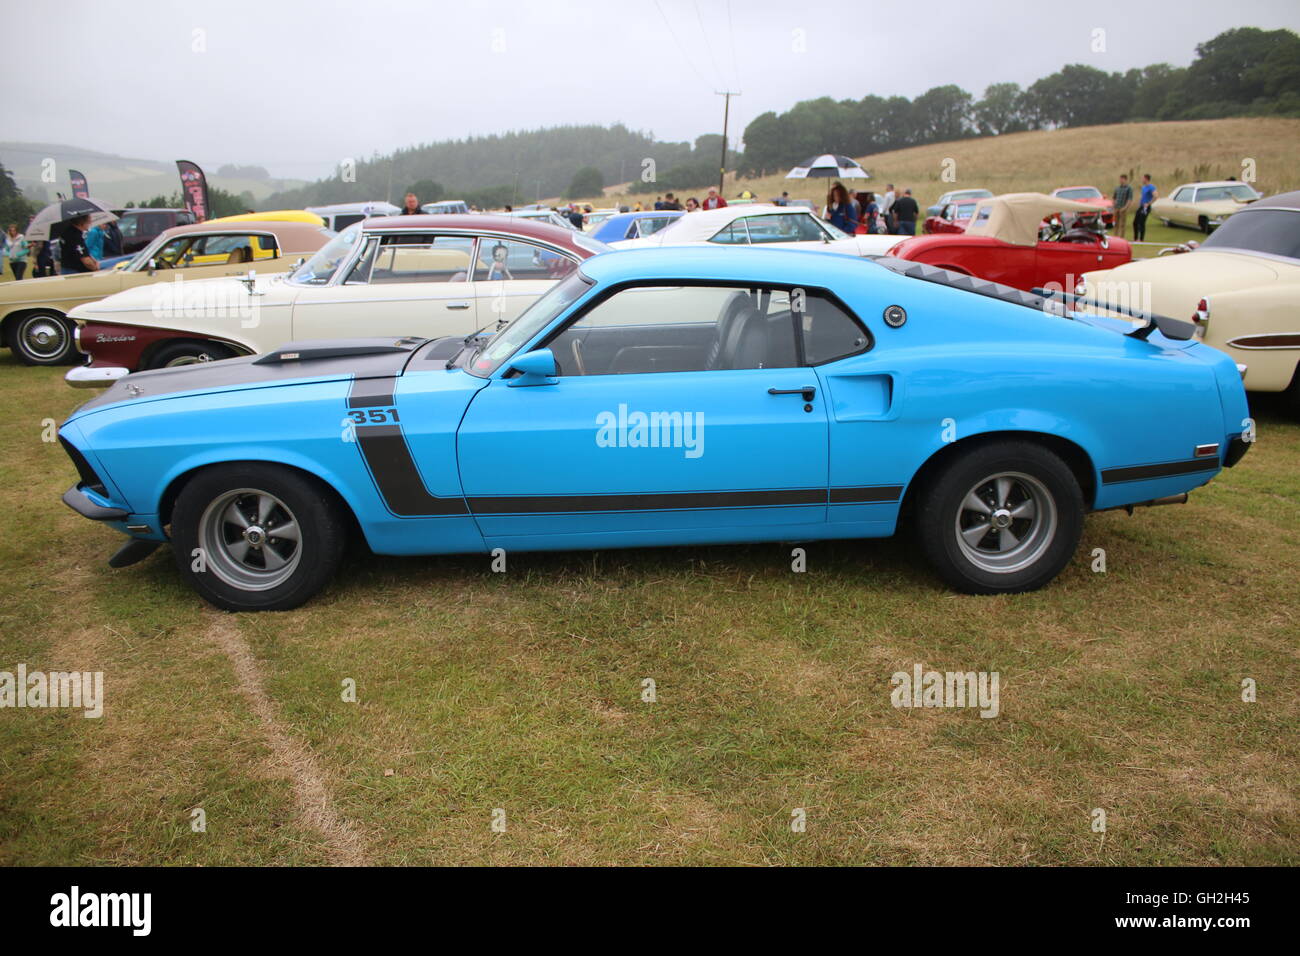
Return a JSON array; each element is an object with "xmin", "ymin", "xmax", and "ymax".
[{"xmin": 0, "ymin": 220, "xmax": 330, "ymax": 365}]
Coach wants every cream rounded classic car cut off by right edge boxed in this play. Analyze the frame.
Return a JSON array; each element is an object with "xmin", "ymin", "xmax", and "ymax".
[{"xmin": 1076, "ymin": 191, "xmax": 1300, "ymax": 414}]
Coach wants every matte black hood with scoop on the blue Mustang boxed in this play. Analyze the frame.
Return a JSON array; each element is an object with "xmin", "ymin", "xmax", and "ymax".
[{"xmin": 68, "ymin": 337, "xmax": 447, "ymax": 421}]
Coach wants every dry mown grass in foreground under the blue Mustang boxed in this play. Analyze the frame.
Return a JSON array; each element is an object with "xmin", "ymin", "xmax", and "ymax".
[{"xmin": 0, "ymin": 352, "xmax": 1300, "ymax": 866}]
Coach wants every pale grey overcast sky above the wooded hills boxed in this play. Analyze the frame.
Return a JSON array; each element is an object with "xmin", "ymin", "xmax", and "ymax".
[{"xmin": 0, "ymin": 0, "xmax": 1300, "ymax": 178}]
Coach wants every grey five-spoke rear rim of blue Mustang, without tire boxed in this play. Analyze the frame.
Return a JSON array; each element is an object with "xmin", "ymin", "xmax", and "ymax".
[{"xmin": 954, "ymin": 472, "xmax": 1057, "ymax": 574}]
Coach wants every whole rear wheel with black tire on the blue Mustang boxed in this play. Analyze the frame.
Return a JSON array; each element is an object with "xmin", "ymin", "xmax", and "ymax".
[{"xmin": 917, "ymin": 441, "xmax": 1084, "ymax": 594}]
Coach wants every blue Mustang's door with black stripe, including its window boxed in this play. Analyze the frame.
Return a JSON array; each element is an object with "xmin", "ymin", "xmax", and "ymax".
[{"xmin": 458, "ymin": 284, "xmax": 827, "ymax": 548}]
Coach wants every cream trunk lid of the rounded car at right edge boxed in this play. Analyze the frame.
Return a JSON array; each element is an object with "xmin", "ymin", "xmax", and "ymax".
[{"xmin": 1084, "ymin": 248, "xmax": 1278, "ymax": 319}]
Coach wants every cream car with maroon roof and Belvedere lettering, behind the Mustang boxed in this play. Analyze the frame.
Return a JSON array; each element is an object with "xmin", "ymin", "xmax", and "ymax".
[{"xmin": 65, "ymin": 215, "xmax": 607, "ymax": 388}]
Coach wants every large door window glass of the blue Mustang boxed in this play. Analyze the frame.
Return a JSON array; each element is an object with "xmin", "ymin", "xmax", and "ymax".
[{"xmin": 549, "ymin": 285, "xmax": 798, "ymax": 376}]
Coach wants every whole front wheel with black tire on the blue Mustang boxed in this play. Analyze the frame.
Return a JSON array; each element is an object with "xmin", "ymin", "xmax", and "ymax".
[{"xmin": 172, "ymin": 462, "xmax": 348, "ymax": 611}]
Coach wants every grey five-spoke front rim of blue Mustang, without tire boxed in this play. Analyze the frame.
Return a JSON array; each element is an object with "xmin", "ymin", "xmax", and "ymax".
[{"xmin": 199, "ymin": 488, "xmax": 302, "ymax": 591}]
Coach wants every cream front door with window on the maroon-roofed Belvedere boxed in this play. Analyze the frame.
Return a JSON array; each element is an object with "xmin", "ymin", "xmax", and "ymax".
[{"xmin": 294, "ymin": 230, "xmax": 490, "ymax": 339}]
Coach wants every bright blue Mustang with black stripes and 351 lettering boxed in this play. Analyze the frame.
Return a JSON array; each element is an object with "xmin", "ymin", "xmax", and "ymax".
[{"xmin": 60, "ymin": 248, "xmax": 1253, "ymax": 610}]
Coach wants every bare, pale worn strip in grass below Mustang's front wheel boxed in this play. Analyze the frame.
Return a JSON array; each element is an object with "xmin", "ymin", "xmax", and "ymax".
[{"xmin": 205, "ymin": 610, "xmax": 371, "ymax": 866}]
